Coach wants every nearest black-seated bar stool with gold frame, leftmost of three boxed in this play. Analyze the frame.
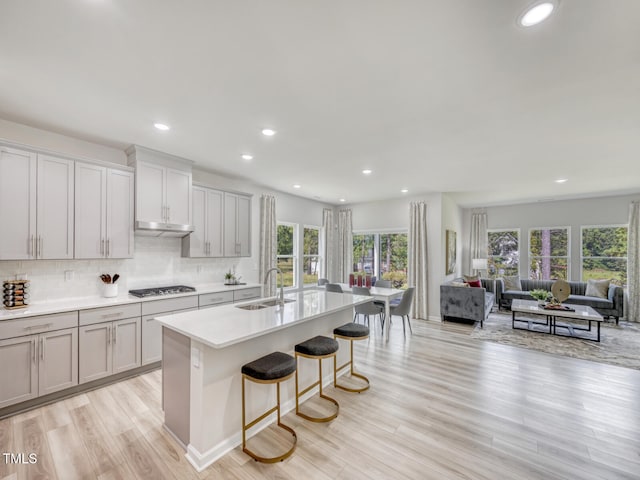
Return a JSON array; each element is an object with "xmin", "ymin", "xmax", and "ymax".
[{"xmin": 242, "ymin": 352, "xmax": 298, "ymax": 463}]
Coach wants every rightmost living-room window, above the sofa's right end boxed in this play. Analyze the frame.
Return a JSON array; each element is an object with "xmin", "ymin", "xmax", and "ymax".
[{"xmin": 581, "ymin": 225, "xmax": 628, "ymax": 286}]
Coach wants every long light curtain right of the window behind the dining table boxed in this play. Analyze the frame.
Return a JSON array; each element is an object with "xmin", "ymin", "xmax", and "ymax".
[{"xmin": 407, "ymin": 202, "xmax": 429, "ymax": 320}]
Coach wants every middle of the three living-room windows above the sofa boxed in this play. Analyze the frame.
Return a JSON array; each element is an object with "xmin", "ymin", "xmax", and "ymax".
[{"xmin": 529, "ymin": 227, "xmax": 570, "ymax": 280}]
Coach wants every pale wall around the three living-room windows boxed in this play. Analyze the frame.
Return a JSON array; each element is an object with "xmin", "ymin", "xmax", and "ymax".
[{"xmin": 463, "ymin": 194, "xmax": 640, "ymax": 281}]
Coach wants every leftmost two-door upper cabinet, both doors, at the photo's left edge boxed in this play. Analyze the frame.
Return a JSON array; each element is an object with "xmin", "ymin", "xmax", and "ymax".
[{"xmin": 0, "ymin": 147, "xmax": 74, "ymax": 260}]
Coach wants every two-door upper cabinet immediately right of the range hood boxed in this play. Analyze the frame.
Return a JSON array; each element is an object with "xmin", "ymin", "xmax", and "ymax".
[{"xmin": 182, "ymin": 186, "xmax": 224, "ymax": 257}]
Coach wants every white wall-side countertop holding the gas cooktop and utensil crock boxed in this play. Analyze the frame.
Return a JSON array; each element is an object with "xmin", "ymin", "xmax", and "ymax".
[{"xmin": 0, "ymin": 283, "xmax": 262, "ymax": 321}]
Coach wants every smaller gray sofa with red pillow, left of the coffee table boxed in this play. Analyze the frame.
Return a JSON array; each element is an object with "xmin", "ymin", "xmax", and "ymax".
[{"xmin": 440, "ymin": 279, "xmax": 495, "ymax": 327}]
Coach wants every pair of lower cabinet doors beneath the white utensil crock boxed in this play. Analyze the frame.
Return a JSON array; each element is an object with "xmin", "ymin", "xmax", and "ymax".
[{"xmin": 78, "ymin": 317, "xmax": 141, "ymax": 383}]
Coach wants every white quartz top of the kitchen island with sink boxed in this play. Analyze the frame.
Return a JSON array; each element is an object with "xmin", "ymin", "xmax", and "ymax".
[{"xmin": 156, "ymin": 290, "xmax": 371, "ymax": 348}]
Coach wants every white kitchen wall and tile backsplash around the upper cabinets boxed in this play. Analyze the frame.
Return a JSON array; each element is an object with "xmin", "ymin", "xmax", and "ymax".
[{"xmin": 0, "ymin": 120, "xmax": 336, "ymax": 302}]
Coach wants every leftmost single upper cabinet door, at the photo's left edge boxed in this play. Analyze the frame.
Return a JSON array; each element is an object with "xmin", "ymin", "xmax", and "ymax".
[{"xmin": 0, "ymin": 146, "xmax": 37, "ymax": 260}]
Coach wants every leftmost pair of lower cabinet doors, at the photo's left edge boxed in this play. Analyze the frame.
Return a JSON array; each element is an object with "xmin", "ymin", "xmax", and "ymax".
[{"xmin": 0, "ymin": 327, "xmax": 78, "ymax": 408}]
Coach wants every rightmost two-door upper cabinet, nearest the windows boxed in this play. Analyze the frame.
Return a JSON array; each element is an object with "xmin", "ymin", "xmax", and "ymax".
[{"xmin": 224, "ymin": 192, "xmax": 251, "ymax": 257}]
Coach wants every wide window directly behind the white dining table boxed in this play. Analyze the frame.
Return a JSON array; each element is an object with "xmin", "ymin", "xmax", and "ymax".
[{"xmin": 353, "ymin": 232, "xmax": 407, "ymax": 288}]
